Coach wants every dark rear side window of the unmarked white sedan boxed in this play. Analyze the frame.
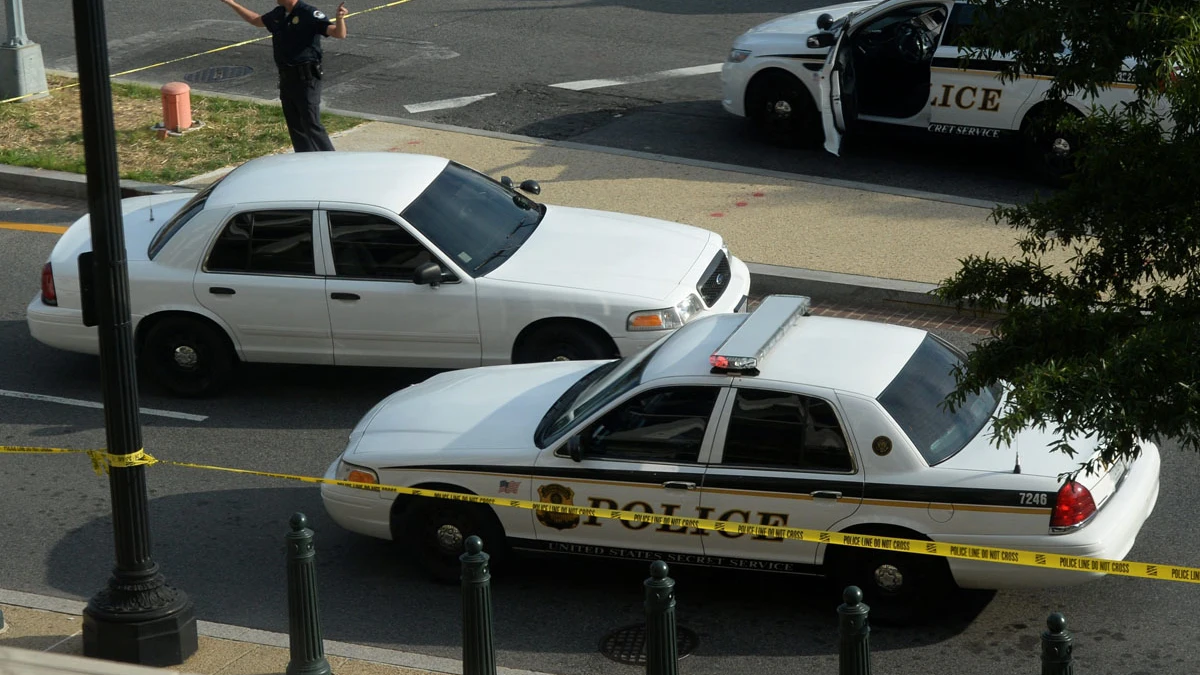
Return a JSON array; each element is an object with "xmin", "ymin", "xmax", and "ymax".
[{"xmin": 205, "ymin": 210, "xmax": 316, "ymax": 274}]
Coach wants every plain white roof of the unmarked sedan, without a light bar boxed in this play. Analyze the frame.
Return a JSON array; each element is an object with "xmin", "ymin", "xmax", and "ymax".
[{"xmin": 208, "ymin": 151, "xmax": 449, "ymax": 213}]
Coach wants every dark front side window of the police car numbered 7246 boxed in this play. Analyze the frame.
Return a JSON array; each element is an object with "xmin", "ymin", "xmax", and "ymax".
[{"xmin": 582, "ymin": 387, "xmax": 720, "ymax": 464}]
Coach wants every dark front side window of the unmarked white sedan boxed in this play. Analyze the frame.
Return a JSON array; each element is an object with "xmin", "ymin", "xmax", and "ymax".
[{"xmin": 329, "ymin": 211, "xmax": 433, "ymax": 281}]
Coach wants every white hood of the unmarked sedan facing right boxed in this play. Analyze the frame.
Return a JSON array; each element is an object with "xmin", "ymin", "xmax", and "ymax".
[{"xmin": 486, "ymin": 204, "xmax": 721, "ymax": 300}]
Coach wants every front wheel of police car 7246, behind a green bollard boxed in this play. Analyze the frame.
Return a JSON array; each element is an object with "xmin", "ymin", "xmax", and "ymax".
[{"xmin": 400, "ymin": 497, "xmax": 506, "ymax": 584}]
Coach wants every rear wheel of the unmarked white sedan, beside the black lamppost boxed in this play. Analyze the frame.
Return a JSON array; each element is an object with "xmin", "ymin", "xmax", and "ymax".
[{"xmin": 138, "ymin": 316, "xmax": 236, "ymax": 396}]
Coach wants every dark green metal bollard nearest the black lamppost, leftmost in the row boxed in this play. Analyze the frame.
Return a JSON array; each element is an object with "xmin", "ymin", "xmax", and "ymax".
[{"xmin": 286, "ymin": 513, "xmax": 330, "ymax": 675}]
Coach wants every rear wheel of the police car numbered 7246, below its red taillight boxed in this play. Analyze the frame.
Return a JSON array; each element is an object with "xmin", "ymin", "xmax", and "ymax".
[{"xmin": 826, "ymin": 537, "xmax": 956, "ymax": 625}]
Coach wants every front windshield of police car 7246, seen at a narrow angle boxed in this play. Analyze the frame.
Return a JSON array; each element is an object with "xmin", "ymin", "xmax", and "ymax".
[{"xmin": 534, "ymin": 335, "xmax": 670, "ymax": 448}]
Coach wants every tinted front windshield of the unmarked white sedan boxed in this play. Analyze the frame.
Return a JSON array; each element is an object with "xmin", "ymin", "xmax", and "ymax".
[{"xmin": 400, "ymin": 162, "xmax": 546, "ymax": 276}]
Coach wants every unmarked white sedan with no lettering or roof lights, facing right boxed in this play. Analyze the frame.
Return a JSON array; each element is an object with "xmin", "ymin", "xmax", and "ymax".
[{"xmin": 26, "ymin": 153, "xmax": 750, "ymax": 395}]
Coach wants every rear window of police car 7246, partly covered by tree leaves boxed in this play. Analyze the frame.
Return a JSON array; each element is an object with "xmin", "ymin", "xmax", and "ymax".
[{"xmin": 878, "ymin": 335, "xmax": 1001, "ymax": 466}]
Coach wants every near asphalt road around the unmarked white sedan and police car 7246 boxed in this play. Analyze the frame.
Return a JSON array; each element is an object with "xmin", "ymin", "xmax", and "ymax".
[{"xmin": 0, "ymin": 195, "xmax": 1200, "ymax": 675}]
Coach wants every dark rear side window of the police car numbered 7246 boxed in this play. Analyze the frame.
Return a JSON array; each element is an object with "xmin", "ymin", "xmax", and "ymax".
[{"xmin": 721, "ymin": 389, "xmax": 854, "ymax": 472}]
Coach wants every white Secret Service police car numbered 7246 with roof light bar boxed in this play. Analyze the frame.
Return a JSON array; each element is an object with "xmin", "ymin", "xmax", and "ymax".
[{"xmin": 320, "ymin": 295, "xmax": 1159, "ymax": 608}]
